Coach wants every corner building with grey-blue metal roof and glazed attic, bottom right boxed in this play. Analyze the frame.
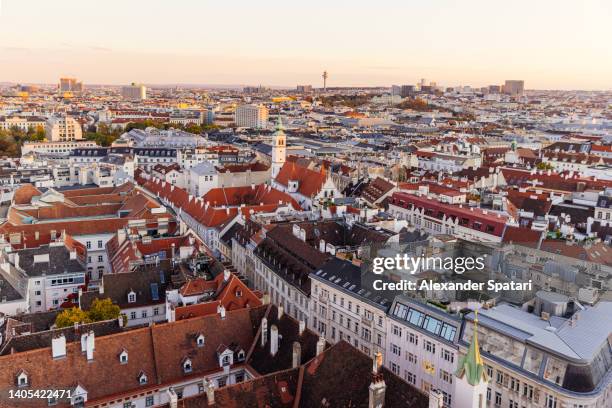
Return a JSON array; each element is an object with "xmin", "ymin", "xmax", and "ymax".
[{"xmin": 460, "ymin": 299, "xmax": 612, "ymax": 408}]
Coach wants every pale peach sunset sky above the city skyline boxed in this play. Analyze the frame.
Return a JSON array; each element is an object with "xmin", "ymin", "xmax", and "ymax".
[{"xmin": 0, "ymin": 0, "xmax": 612, "ymax": 90}]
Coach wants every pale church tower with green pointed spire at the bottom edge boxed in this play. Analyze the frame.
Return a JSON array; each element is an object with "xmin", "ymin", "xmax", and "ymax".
[{"xmin": 453, "ymin": 310, "xmax": 489, "ymax": 408}]
